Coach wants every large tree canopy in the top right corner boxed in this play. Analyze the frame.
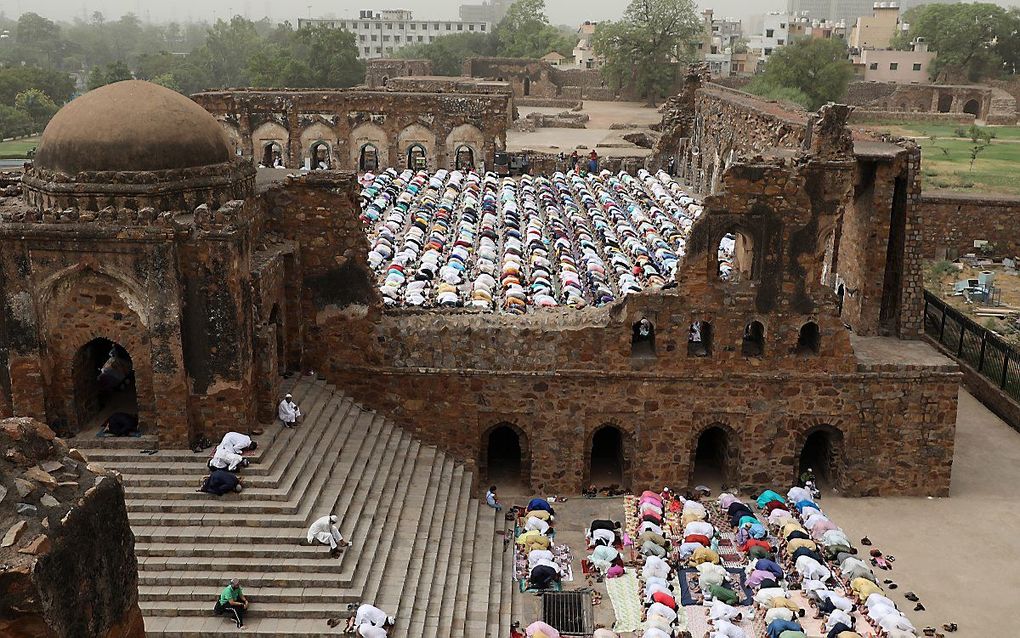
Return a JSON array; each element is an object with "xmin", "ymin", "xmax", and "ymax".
[{"xmin": 895, "ymin": 2, "xmax": 1020, "ymax": 82}]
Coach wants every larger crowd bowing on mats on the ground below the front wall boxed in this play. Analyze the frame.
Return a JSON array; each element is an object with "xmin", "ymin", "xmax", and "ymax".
[{"xmin": 575, "ymin": 477, "xmax": 934, "ymax": 638}]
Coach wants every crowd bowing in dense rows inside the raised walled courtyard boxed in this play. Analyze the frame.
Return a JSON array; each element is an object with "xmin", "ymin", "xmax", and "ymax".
[{"xmin": 360, "ymin": 168, "xmax": 703, "ymax": 314}]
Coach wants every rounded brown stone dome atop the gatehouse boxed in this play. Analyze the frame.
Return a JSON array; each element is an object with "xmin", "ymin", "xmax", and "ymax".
[{"xmin": 34, "ymin": 80, "xmax": 233, "ymax": 175}]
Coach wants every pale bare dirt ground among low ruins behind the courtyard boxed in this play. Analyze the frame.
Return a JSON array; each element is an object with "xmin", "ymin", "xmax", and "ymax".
[{"xmin": 507, "ymin": 100, "xmax": 662, "ymax": 156}]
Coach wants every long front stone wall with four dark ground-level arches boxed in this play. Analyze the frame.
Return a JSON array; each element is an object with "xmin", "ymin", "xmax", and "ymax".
[{"xmin": 291, "ymin": 159, "xmax": 958, "ymax": 494}]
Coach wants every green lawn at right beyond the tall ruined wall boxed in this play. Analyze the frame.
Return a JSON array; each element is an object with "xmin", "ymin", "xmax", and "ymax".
[{"xmin": 864, "ymin": 121, "xmax": 1020, "ymax": 195}]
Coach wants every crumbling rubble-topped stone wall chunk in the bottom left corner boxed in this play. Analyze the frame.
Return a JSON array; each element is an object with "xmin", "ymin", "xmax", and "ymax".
[{"xmin": 0, "ymin": 419, "xmax": 145, "ymax": 638}]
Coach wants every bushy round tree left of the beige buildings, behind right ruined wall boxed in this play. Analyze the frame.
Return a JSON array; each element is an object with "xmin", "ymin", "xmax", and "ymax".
[{"xmin": 749, "ymin": 39, "xmax": 854, "ymax": 110}]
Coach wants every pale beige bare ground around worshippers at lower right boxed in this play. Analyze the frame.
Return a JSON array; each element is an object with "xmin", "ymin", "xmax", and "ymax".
[{"xmin": 503, "ymin": 390, "xmax": 1020, "ymax": 638}]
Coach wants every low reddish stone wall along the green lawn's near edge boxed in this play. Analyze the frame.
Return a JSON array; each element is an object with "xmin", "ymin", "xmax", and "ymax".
[{"xmin": 918, "ymin": 191, "xmax": 1020, "ymax": 259}]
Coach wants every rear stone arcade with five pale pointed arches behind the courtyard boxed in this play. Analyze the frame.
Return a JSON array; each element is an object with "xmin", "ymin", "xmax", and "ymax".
[{"xmin": 192, "ymin": 89, "xmax": 513, "ymax": 170}]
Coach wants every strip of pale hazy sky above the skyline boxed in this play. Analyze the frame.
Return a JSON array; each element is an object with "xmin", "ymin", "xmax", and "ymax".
[{"xmin": 0, "ymin": 0, "xmax": 1020, "ymax": 24}]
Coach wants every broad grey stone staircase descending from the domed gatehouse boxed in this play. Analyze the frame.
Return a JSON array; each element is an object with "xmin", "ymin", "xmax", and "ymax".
[{"xmin": 69, "ymin": 379, "xmax": 513, "ymax": 638}]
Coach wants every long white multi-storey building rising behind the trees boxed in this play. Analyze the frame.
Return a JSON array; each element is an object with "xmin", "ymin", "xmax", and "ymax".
[{"xmin": 298, "ymin": 9, "xmax": 493, "ymax": 59}]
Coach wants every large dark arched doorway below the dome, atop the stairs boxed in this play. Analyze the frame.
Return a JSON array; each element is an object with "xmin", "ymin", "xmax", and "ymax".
[{"xmin": 71, "ymin": 338, "xmax": 138, "ymax": 432}]
